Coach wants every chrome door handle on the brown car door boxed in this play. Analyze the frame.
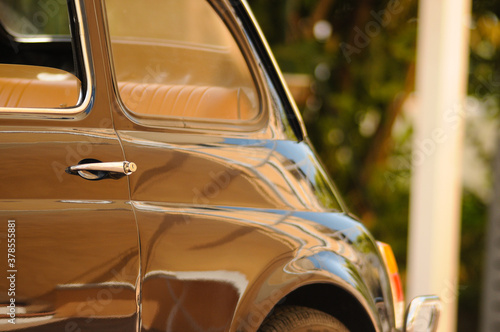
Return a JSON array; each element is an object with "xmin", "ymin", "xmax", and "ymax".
[{"xmin": 66, "ymin": 161, "xmax": 137, "ymax": 180}]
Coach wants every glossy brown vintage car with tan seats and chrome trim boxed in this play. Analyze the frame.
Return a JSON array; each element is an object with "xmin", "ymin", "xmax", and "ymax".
[{"xmin": 0, "ymin": 0, "xmax": 439, "ymax": 332}]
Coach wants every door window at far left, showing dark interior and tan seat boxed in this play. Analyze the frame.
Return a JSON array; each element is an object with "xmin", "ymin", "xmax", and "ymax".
[{"xmin": 0, "ymin": 0, "xmax": 84, "ymax": 111}]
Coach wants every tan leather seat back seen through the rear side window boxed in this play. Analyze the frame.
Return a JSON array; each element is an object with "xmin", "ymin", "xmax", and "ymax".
[{"xmin": 118, "ymin": 82, "xmax": 257, "ymax": 120}]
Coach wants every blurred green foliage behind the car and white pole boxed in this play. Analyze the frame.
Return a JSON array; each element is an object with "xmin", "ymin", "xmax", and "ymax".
[{"xmin": 248, "ymin": 0, "xmax": 500, "ymax": 331}]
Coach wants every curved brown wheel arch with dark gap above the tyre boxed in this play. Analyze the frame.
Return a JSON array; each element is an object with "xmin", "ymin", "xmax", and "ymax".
[{"xmin": 231, "ymin": 253, "xmax": 382, "ymax": 332}]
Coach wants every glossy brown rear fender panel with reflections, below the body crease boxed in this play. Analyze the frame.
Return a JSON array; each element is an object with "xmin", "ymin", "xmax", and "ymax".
[{"xmin": 133, "ymin": 202, "xmax": 390, "ymax": 331}]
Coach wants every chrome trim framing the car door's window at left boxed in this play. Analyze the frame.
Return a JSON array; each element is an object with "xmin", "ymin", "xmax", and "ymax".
[{"xmin": 0, "ymin": 0, "xmax": 94, "ymax": 118}]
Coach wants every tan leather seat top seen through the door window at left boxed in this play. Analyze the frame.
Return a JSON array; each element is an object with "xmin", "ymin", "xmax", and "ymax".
[{"xmin": 0, "ymin": 64, "xmax": 81, "ymax": 108}]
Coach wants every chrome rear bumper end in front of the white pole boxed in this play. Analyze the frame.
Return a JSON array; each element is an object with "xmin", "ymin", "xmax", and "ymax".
[{"xmin": 403, "ymin": 296, "xmax": 441, "ymax": 332}]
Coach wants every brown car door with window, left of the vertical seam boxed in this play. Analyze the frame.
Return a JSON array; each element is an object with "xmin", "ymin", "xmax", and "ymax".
[{"xmin": 0, "ymin": 0, "xmax": 140, "ymax": 332}]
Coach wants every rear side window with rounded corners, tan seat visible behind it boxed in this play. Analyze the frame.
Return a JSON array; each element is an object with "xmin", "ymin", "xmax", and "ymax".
[{"xmin": 105, "ymin": 0, "xmax": 260, "ymax": 121}]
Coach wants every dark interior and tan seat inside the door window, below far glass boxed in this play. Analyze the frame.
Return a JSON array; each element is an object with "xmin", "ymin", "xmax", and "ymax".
[{"xmin": 0, "ymin": 0, "xmax": 85, "ymax": 109}]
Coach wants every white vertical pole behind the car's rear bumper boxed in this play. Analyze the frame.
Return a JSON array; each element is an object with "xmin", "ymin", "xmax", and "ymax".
[{"xmin": 407, "ymin": 0, "xmax": 471, "ymax": 332}]
